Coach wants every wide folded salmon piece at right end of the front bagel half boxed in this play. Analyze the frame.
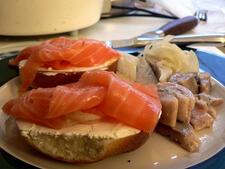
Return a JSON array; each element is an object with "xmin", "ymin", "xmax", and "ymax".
[{"xmin": 80, "ymin": 71, "xmax": 161, "ymax": 132}]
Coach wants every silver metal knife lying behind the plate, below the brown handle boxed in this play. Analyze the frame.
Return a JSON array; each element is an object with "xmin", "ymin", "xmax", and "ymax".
[{"xmin": 105, "ymin": 33, "xmax": 225, "ymax": 48}]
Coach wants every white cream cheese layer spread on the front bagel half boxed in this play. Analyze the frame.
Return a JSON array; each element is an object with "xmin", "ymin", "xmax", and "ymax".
[{"xmin": 17, "ymin": 112, "xmax": 141, "ymax": 139}]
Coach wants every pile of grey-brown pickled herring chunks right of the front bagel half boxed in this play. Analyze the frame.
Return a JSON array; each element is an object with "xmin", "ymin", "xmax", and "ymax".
[{"xmin": 156, "ymin": 79, "xmax": 223, "ymax": 152}]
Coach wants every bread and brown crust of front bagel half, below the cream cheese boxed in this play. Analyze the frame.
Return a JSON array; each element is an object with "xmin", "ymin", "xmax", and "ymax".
[{"xmin": 17, "ymin": 118, "xmax": 149, "ymax": 163}]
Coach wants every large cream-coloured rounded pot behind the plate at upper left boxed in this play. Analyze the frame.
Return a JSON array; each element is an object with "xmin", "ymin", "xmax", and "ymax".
[{"xmin": 0, "ymin": 0, "xmax": 104, "ymax": 36}]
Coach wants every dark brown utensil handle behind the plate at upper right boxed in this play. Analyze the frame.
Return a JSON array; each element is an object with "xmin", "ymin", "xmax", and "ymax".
[{"xmin": 155, "ymin": 16, "xmax": 198, "ymax": 35}]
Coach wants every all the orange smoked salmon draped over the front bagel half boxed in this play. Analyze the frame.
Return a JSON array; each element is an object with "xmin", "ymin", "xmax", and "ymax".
[{"xmin": 3, "ymin": 70, "xmax": 161, "ymax": 132}]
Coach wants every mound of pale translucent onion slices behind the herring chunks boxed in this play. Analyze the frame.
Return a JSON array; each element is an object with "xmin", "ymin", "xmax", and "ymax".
[{"xmin": 143, "ymin": 41, "xmax": 199, "ymax": 82}]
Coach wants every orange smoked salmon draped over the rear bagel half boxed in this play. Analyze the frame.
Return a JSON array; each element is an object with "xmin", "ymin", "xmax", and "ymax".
[{"xmin": 10, "ymin": 37, "xmax": 120, "ymax": 92}]
